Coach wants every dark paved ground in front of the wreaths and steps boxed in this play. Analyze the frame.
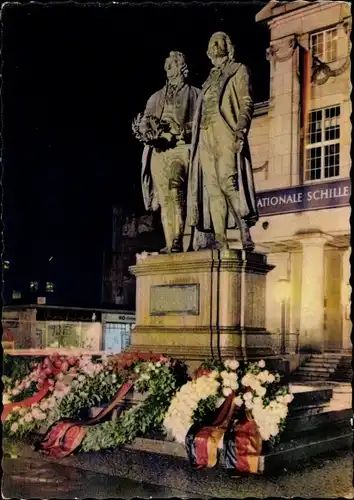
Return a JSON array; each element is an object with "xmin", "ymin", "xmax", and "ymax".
[{"xmin": 3, "ymin": 440, "xmax": 353, "ymax": 498}]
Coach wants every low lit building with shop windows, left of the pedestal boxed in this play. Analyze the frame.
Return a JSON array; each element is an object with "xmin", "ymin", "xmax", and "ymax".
[{"xmin": 2, "ymin": 304, "xmax": 135, "ymax": 354}]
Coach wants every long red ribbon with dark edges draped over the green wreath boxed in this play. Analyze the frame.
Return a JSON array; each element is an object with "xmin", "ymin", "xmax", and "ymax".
[{"xmin": 36, "ymin": 380, "xmax": 134, "ymax": 458}]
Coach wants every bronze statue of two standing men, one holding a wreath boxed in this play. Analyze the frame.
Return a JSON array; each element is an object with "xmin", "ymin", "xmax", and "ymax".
[{"xmin": 133, "ymin": 32, "xmax": 258, "ymax": 253}]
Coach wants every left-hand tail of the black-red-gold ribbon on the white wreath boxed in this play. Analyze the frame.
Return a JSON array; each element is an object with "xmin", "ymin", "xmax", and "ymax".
[{"xmin": 185, "ymin": 393, "xmax": 235, "ymax": 469}]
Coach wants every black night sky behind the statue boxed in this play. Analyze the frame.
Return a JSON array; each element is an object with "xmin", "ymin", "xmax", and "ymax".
[{"xmin": 2, "ymin": 2, "xmax": 269, "ymax": 305}]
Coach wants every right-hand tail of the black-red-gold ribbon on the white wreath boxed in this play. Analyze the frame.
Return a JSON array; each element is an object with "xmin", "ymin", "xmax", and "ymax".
[{"xmin": 224, "ymin": 410, "xmax": 262, "ymax": 474}]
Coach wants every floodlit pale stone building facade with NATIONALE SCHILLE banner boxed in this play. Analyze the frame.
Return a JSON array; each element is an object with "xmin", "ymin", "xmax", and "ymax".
[{"xmin": 229, "ymin": 0, "xmax": 352, "ymax": 352}]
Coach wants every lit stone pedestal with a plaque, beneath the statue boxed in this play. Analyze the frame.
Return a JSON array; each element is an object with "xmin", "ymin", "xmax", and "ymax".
[{"xmin": 130, "ymin": 250, "xmax": 274, "ymax": 363}]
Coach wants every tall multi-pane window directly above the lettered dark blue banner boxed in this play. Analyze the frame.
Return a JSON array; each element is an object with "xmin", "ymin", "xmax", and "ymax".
[{"xmin": 305, "ymin": 106, "xmax": 340, "ymax": 181}]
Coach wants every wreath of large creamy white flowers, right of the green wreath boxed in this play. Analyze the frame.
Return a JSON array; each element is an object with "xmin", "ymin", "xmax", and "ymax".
[{"xmin": 164, "ymin": 359, "xmax": 293, "ymax": 444}]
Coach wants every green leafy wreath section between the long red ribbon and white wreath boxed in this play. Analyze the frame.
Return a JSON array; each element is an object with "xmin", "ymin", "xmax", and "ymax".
[{"xmin": 82, "ymin": 356, "xmax": 187, "ymax": 451}]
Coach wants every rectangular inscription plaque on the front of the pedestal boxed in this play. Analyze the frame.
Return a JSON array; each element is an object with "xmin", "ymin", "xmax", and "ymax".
[{"xmin": 150, "ymin": 284, "xmax": 199, "ymax": 316}]
